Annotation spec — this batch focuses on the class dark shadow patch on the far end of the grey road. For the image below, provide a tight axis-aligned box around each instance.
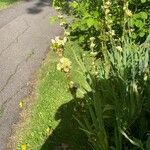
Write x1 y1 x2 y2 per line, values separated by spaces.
27 0 50 14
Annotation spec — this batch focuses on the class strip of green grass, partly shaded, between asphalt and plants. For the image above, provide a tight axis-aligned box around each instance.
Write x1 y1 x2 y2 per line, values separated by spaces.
16 41 90 150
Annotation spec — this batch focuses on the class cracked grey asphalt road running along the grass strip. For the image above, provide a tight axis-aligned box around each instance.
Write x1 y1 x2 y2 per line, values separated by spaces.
0 0 62 150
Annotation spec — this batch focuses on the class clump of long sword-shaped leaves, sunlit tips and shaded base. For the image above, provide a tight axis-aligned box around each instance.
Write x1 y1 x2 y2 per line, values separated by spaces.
74 37 150 150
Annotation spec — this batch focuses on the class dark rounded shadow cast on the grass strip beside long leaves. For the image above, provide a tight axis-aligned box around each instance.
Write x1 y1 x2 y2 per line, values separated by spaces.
41 94 91 150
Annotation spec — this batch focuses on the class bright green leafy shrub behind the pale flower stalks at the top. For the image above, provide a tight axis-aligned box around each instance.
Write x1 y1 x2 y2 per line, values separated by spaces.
55 0 150 47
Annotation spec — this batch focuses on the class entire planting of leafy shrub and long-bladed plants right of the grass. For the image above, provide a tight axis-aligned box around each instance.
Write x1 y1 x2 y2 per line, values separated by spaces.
51 0 150 150
